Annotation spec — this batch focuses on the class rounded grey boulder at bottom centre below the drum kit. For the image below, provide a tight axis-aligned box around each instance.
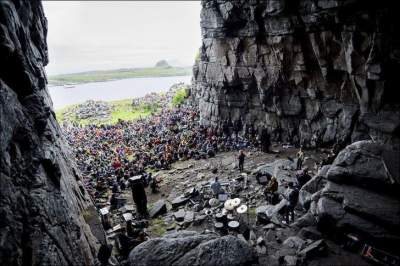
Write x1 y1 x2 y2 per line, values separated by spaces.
129 231 257 266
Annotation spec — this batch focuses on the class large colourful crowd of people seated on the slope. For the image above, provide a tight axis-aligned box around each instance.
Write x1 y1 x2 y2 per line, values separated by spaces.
63 106 257 206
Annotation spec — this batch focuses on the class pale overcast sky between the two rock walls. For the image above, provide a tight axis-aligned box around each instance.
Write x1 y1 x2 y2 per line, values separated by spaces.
43 1 201 75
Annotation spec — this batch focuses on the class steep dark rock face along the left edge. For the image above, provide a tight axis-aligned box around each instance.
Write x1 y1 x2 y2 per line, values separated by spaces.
0 0 98 265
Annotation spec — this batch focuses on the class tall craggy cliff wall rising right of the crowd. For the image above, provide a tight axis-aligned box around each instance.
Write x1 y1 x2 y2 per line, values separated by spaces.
191 0 400 146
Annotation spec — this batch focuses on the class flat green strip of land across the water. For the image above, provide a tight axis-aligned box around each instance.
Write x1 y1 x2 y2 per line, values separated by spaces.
48 67 191 86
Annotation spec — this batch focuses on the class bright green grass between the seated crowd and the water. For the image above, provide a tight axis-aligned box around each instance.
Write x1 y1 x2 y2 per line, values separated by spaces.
56 99 160 125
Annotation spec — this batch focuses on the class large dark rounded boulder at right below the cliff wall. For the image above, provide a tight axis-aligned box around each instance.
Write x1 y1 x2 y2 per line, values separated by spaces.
315 141 400 249
